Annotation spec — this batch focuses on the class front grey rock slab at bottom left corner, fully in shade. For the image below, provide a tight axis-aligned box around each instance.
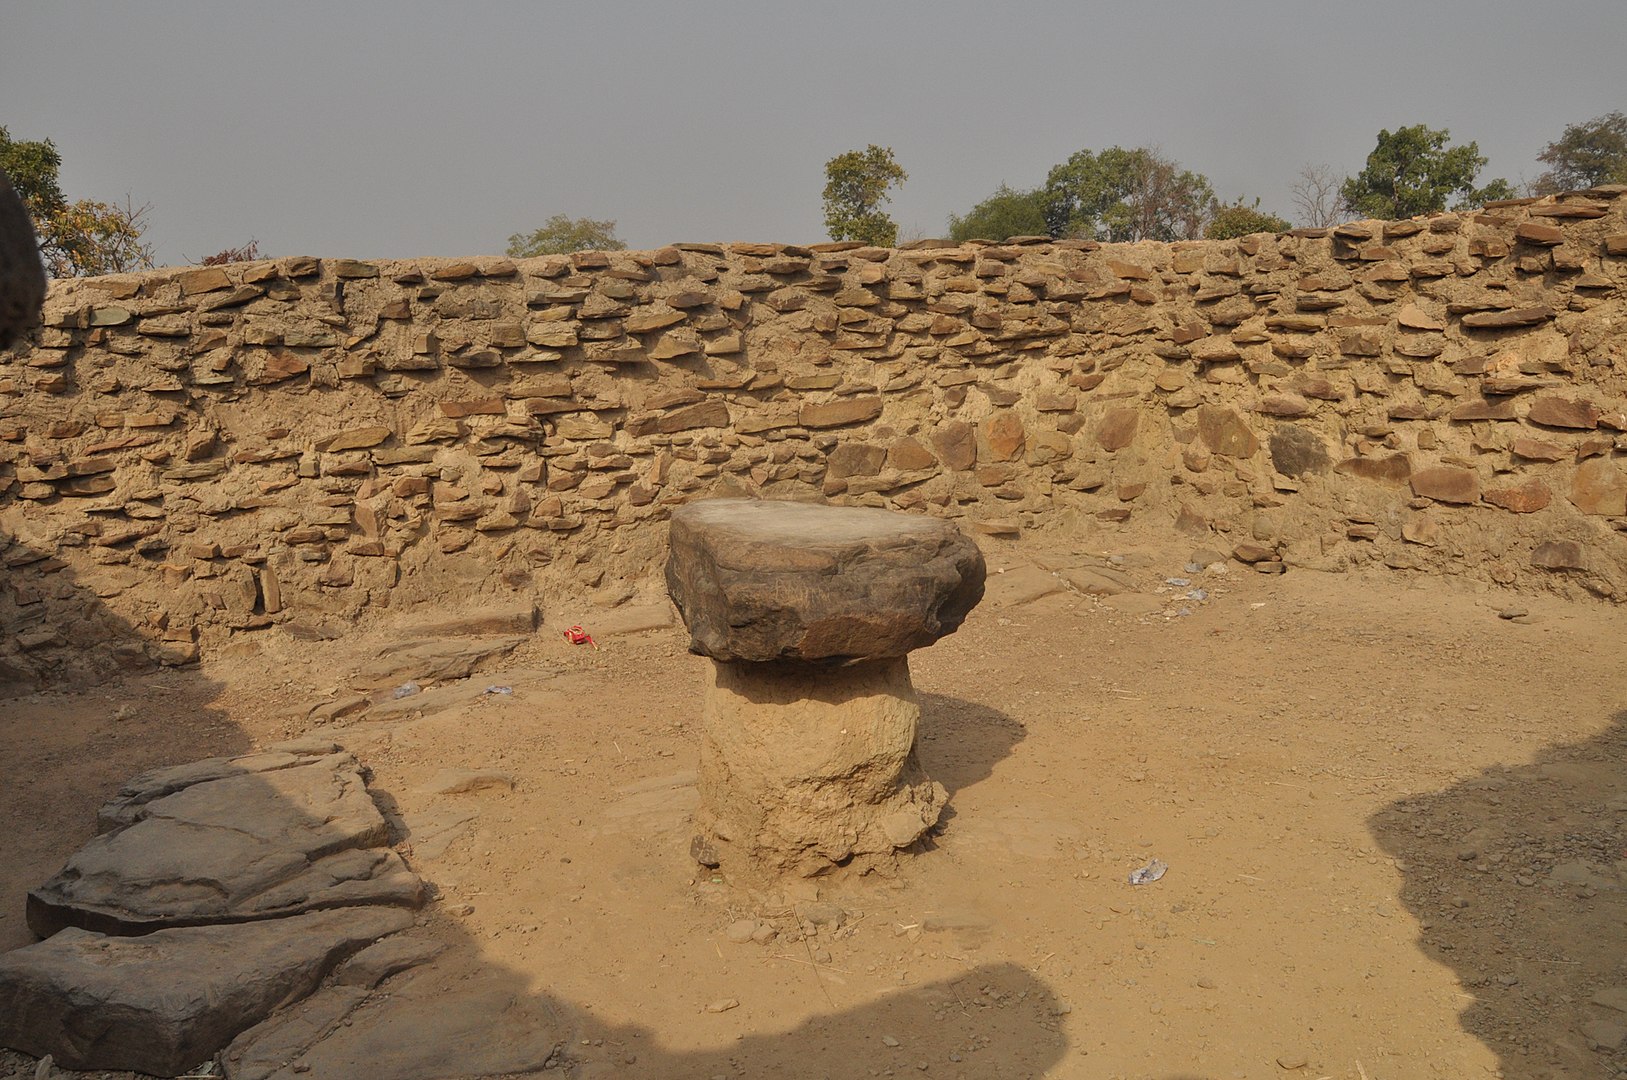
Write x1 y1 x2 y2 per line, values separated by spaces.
0 908 413 1077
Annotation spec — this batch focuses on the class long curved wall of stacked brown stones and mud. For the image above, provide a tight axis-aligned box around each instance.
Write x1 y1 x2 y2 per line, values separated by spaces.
0 187 1627 683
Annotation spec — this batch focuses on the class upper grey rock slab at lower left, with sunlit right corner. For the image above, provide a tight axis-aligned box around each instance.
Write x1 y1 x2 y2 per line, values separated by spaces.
28 753 423 937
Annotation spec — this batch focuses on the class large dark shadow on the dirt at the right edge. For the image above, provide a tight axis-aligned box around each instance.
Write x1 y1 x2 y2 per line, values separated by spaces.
1368 711 1627 1080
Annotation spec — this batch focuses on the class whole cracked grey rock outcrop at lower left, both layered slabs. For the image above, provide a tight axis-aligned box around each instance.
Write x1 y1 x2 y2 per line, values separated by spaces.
0 740 423 1077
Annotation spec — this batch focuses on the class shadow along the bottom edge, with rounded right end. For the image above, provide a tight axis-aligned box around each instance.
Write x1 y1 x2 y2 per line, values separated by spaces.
244 950 1067 1080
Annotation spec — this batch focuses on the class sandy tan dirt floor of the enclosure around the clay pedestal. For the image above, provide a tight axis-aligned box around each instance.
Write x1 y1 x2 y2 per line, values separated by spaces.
0 537 1627 1080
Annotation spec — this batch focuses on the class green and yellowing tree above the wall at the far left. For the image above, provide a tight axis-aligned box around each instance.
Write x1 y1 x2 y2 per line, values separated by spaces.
0 127 153 278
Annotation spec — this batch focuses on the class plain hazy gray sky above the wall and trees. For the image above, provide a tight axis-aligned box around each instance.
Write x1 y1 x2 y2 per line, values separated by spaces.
0 0 1627 263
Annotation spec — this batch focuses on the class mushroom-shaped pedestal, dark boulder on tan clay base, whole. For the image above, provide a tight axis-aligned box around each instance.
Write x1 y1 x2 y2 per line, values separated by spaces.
667 499 984 877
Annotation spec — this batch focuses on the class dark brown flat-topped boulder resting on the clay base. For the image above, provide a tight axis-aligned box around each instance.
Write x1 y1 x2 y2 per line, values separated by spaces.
667 499 984 662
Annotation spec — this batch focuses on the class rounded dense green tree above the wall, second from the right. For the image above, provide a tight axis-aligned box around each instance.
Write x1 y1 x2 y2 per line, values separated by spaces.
1339 124 1515 220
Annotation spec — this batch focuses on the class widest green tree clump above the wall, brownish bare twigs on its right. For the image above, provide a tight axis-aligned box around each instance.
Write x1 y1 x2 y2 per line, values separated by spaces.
1043 146 1215 241
